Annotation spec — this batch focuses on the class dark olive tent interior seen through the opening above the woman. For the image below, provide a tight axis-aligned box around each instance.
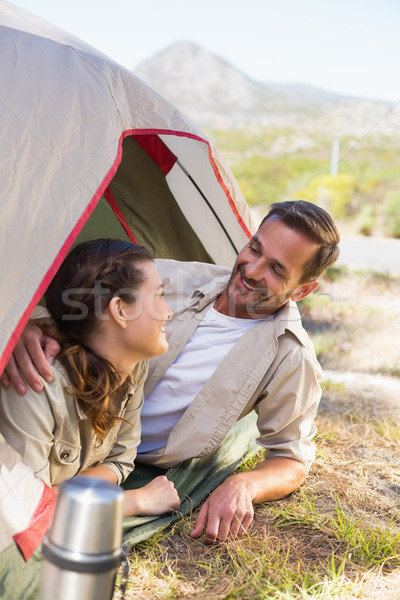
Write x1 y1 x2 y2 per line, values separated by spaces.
74 136 214 263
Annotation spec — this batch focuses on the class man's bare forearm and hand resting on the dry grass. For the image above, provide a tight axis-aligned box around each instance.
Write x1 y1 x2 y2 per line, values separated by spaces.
190 456 307 543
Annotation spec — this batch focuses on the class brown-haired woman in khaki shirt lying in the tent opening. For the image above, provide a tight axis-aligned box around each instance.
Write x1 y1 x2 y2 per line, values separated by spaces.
0 240 179 516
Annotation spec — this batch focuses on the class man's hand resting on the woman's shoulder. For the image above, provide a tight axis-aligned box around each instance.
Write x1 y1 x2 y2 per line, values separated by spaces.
0 323 60 394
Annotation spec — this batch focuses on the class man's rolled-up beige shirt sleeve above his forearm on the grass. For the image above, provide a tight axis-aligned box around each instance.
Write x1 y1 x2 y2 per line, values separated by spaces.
255 347 321 470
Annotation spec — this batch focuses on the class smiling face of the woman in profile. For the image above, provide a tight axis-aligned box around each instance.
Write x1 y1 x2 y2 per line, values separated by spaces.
125 261 172 361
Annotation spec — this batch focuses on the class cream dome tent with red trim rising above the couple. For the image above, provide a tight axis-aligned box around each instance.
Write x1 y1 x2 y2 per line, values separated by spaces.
0 0 252 372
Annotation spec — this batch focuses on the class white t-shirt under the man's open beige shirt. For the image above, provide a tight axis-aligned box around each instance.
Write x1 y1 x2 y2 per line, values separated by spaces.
138 306 259 452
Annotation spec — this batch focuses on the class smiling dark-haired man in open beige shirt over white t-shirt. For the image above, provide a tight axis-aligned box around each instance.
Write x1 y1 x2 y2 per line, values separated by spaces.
3 200 339 543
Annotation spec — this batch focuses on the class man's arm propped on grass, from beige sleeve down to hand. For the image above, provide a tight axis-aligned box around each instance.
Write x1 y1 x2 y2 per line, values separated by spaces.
191 338 321 543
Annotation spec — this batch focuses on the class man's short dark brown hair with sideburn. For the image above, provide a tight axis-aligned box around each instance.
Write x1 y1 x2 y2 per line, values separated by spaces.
260 200 340 283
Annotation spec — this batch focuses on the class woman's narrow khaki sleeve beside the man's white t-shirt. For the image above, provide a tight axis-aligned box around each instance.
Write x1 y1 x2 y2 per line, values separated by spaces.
103 361 148 484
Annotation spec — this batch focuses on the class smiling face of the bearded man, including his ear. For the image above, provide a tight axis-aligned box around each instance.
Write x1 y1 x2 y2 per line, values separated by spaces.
220 218 319 319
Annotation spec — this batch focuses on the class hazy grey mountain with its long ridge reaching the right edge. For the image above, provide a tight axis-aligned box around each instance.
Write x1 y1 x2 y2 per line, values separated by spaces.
134 41 400 136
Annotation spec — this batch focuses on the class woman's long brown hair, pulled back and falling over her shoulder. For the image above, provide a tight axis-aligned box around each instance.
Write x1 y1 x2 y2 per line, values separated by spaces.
43 239 152 442
